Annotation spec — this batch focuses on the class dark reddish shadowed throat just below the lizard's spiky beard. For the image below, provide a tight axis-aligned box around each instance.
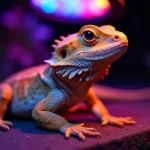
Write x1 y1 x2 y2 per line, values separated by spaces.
52 65 108 97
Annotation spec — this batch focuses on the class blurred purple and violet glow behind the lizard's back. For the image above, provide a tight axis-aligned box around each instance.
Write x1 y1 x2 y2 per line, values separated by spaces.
0 6 55 77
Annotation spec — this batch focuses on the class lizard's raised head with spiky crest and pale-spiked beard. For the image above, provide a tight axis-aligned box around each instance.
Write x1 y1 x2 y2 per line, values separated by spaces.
46 25 128 82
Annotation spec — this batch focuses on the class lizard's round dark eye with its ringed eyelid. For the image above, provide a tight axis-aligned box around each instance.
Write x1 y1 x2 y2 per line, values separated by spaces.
82 31 97 45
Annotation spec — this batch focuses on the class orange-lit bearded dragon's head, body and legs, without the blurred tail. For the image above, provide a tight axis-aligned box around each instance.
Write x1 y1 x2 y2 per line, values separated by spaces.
0 25 135 140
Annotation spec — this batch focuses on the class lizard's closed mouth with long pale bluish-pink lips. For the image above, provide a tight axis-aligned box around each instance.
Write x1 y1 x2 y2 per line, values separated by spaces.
77 44 127 61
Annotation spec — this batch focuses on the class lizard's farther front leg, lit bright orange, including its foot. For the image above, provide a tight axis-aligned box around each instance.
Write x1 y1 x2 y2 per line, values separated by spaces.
85 88 135 127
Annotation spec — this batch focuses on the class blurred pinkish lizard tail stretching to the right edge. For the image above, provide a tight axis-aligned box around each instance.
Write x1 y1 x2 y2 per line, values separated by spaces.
93 84 150 101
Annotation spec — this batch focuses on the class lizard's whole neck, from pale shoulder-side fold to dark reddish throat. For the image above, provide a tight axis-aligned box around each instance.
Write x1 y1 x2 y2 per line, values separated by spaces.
42 65 109 98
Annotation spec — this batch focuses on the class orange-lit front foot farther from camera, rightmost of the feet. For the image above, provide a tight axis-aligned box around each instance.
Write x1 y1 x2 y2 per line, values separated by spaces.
101 115 136 127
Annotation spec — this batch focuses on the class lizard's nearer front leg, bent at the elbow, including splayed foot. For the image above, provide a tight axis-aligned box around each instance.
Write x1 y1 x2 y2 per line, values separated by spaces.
32 90 100 140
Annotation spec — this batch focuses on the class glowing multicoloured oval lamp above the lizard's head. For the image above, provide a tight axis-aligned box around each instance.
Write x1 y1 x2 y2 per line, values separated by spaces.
31 0 111 23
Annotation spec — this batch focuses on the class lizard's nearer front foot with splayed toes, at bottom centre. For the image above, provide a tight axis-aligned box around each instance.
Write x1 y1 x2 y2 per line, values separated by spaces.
60 124 101 141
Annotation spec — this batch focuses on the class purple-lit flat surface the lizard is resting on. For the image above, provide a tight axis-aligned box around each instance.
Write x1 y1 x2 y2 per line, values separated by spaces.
0 101 150 150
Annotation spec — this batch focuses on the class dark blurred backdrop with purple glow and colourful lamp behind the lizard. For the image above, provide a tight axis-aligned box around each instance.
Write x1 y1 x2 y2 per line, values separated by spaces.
0 0 150 87
